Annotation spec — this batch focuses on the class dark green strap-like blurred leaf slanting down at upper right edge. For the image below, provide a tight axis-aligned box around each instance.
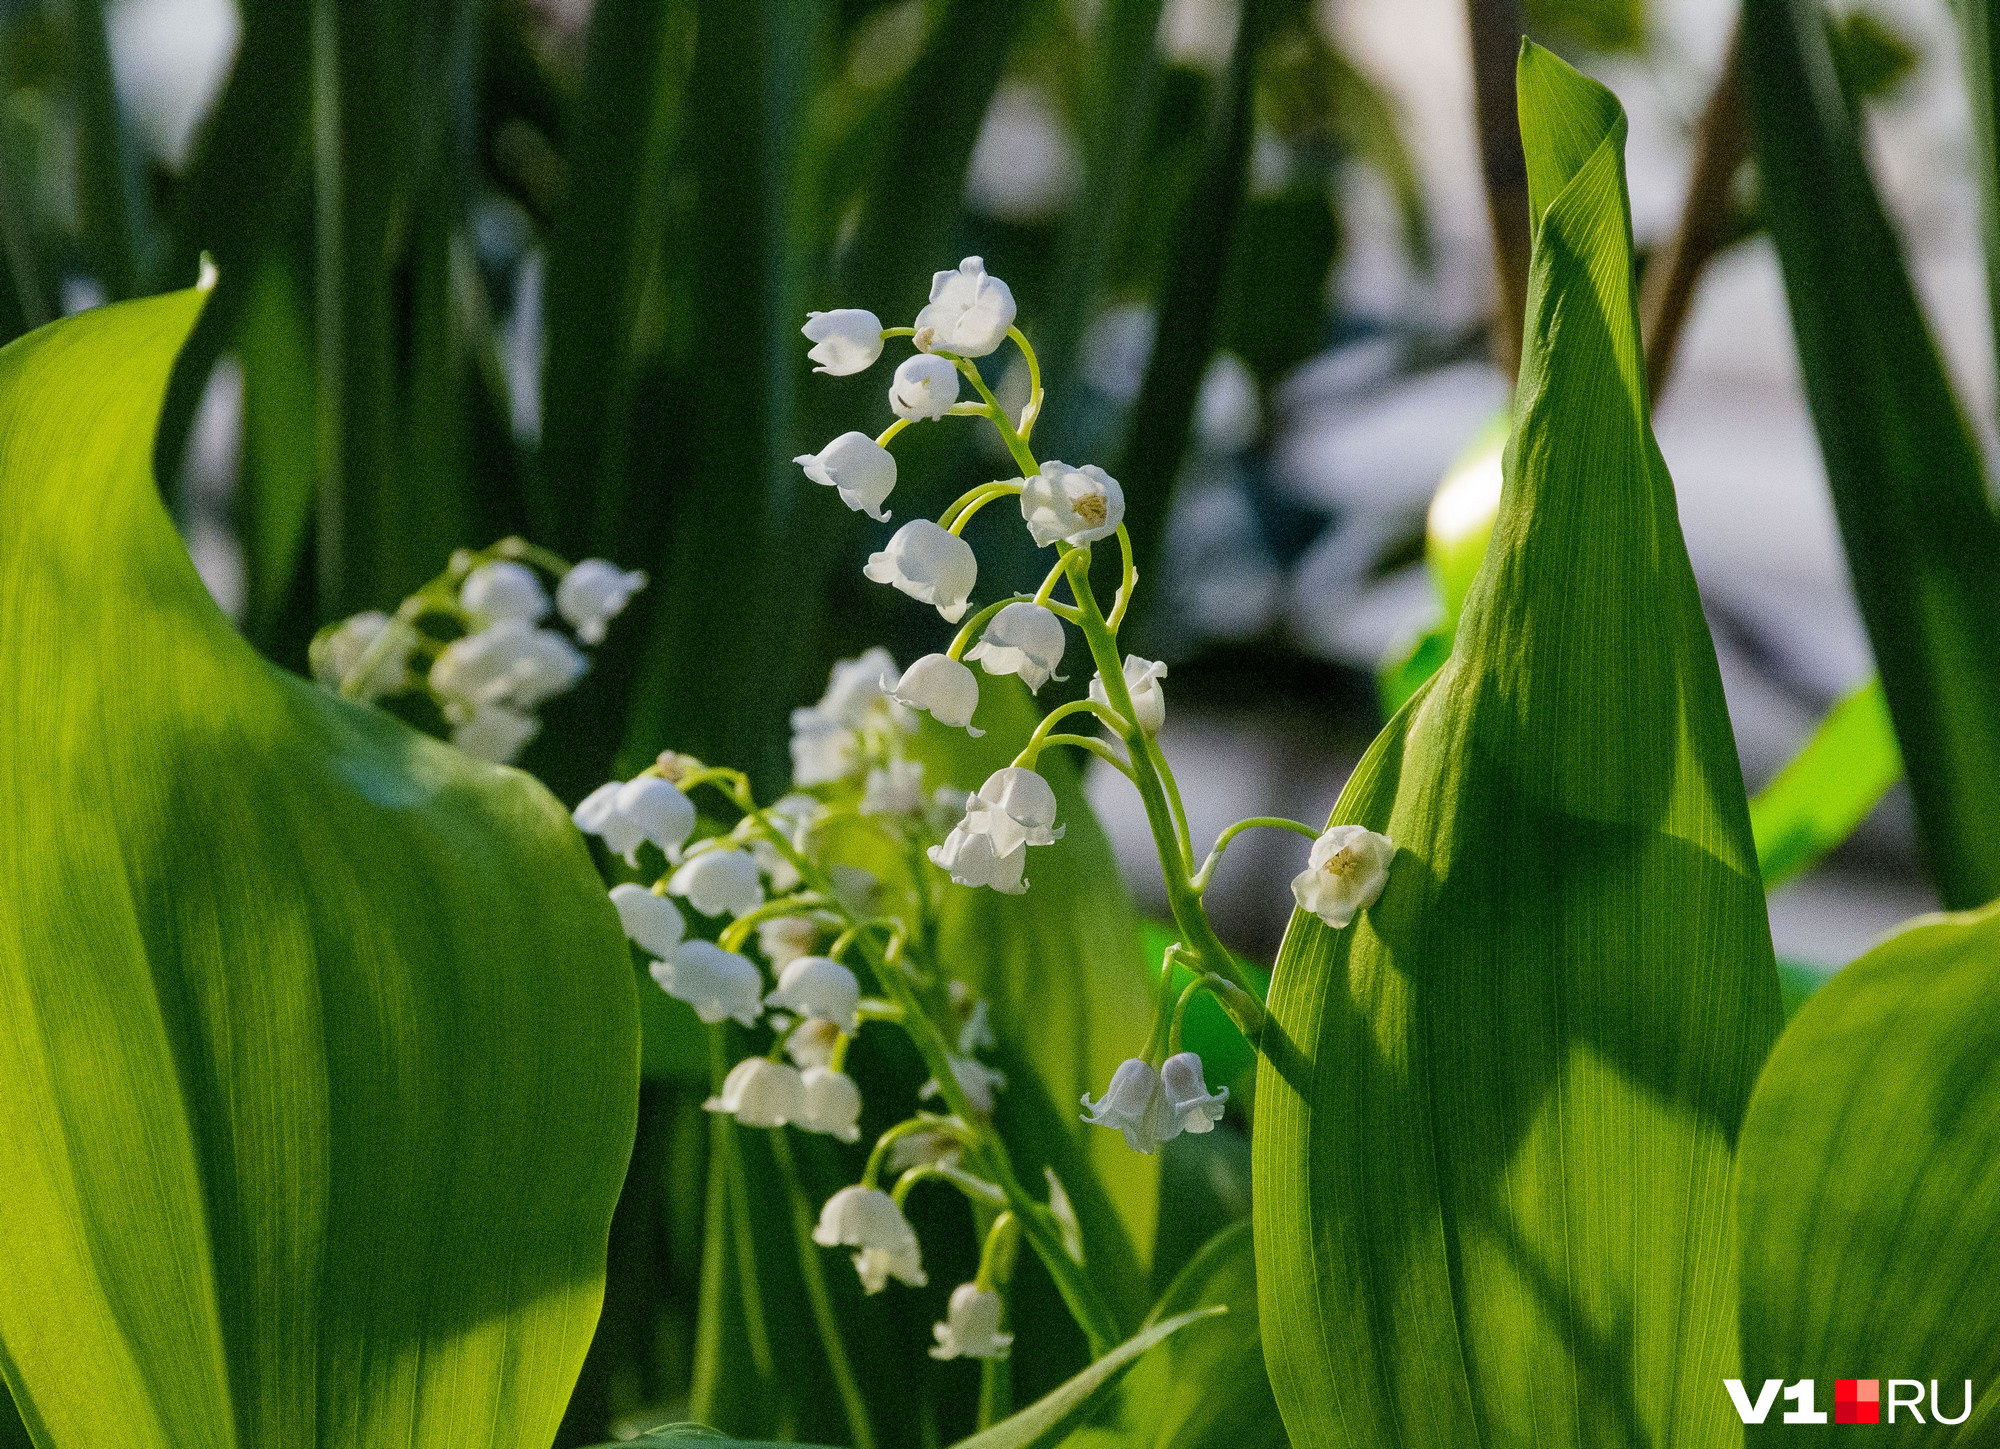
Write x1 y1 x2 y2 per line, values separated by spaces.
1742 0 2000 907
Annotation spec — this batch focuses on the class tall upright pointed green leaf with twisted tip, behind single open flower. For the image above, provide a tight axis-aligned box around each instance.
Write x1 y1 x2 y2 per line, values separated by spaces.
1252 46 1780 1449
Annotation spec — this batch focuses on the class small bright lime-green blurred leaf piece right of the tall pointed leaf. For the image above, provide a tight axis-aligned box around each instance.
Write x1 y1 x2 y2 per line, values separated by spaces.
1750 678 1902 887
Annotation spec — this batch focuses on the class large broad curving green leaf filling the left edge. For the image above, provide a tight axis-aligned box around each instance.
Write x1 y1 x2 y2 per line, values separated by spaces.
0 292 638 1449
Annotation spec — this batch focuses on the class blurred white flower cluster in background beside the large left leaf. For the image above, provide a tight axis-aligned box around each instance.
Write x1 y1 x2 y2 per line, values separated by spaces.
312 540 646 765
